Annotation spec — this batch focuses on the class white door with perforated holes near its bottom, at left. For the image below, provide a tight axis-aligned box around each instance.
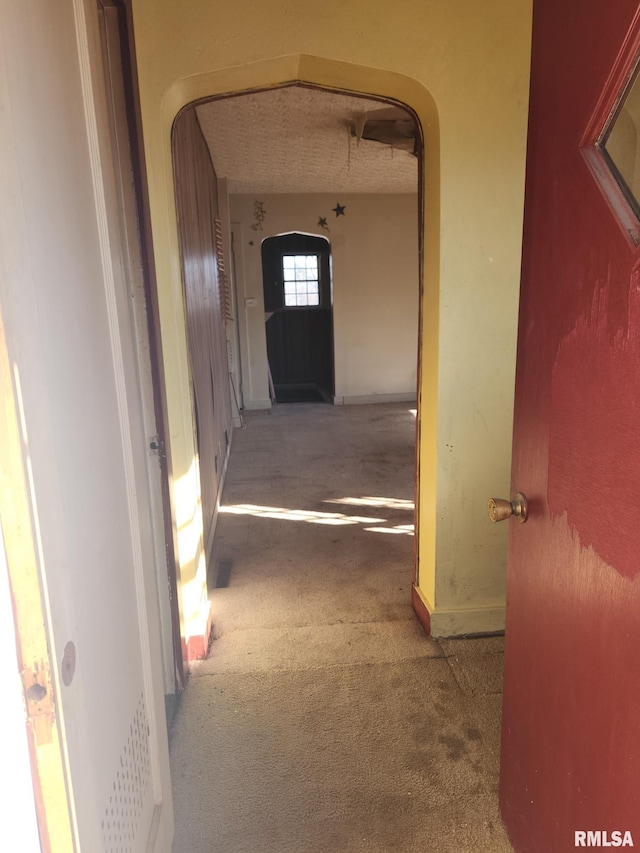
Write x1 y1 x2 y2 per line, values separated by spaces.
0 0 172 853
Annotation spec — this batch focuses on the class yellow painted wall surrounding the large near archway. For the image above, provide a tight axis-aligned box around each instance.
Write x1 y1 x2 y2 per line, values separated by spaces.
133 0 531 634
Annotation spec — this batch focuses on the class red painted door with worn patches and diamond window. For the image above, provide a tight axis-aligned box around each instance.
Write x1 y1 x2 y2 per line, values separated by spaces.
501 0 640 853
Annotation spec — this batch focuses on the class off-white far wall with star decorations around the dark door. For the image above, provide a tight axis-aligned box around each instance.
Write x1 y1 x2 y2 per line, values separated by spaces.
230 194 418 408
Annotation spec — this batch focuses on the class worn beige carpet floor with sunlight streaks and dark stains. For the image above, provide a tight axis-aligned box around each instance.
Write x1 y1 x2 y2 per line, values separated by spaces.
171 404 511 853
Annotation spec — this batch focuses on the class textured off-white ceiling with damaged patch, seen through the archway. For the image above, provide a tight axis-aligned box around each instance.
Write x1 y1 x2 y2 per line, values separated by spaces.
197 86 418 194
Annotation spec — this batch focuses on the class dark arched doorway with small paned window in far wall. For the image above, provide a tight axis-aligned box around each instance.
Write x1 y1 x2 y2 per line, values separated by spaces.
262 233 334 403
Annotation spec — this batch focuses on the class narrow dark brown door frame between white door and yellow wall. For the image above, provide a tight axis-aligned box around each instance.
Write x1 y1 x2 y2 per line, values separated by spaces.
97 0 188 693
